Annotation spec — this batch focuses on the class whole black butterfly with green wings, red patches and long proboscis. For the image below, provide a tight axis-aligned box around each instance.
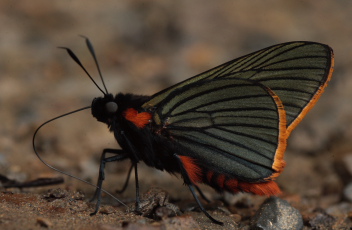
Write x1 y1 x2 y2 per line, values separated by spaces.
33 38 334 224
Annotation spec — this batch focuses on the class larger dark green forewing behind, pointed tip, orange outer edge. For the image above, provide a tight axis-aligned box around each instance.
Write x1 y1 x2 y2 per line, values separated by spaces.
143 42 333 134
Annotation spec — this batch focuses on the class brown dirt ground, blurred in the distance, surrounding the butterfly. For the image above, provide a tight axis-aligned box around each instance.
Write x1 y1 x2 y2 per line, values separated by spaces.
0 0 352 229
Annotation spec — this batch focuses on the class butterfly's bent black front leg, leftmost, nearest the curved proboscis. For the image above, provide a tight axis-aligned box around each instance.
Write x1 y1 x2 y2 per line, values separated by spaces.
90 149 128 215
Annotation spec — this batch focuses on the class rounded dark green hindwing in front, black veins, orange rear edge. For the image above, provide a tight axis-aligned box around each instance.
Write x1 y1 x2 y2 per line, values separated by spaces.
153 78 287 182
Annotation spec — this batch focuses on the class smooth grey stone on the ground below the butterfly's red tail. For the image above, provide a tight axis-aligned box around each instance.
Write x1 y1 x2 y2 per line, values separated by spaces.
251 197 303 230
